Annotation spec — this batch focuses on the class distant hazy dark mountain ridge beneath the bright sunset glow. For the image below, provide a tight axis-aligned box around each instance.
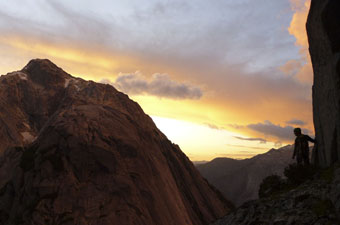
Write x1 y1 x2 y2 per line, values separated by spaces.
196 145 294 206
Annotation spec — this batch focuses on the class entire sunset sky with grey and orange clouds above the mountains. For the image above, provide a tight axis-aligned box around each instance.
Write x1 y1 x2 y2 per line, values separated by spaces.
0 0 314 161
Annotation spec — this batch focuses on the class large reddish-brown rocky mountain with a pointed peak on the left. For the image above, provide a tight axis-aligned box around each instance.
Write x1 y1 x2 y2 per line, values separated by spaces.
0 59 232 225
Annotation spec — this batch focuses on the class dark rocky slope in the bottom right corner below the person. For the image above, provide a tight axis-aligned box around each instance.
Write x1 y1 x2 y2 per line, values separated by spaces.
213 169 340 225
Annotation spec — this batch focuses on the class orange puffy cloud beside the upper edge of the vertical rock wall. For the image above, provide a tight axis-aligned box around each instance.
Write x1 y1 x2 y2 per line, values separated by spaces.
280 0 313 84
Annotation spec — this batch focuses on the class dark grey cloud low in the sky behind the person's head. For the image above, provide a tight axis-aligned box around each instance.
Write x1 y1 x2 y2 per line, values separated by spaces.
247 120 309 141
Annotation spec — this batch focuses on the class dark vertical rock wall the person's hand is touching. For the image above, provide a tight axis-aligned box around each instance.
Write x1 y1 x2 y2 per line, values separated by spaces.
307 0 340 166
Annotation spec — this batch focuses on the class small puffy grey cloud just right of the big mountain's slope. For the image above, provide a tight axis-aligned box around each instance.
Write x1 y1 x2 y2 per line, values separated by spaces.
101 72 203 99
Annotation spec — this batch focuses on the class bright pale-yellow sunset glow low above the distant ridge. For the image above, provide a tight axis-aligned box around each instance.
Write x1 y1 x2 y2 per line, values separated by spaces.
151 116 274 161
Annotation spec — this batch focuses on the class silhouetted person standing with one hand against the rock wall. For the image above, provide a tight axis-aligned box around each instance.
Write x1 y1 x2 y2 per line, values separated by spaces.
293 128 315 165
